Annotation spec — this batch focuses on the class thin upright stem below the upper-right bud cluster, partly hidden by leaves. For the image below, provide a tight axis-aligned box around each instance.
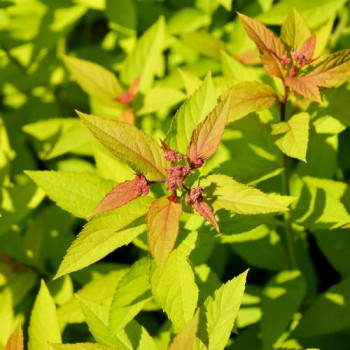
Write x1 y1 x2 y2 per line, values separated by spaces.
280 86 297 269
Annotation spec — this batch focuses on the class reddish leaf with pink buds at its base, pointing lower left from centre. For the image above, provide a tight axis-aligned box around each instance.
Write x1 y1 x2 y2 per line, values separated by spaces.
87 175 149 217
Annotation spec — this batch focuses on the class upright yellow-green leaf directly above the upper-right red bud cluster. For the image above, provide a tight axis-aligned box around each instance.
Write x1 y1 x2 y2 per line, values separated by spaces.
281 8 311 49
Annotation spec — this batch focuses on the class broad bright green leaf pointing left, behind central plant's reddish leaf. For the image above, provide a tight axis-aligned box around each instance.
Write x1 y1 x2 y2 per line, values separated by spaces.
25 171 114 218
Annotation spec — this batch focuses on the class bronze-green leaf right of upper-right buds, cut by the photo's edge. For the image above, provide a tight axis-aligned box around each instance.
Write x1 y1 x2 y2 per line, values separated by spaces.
307 49 350 87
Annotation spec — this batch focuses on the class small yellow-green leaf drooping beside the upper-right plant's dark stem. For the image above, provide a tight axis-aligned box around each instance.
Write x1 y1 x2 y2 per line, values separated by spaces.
272 112 310 162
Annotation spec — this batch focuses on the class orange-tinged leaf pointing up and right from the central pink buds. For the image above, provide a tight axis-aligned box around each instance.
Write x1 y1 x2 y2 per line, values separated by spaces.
187 94 231 162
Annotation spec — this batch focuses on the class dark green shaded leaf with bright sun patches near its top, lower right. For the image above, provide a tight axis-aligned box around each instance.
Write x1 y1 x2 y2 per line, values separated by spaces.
261 271 306 347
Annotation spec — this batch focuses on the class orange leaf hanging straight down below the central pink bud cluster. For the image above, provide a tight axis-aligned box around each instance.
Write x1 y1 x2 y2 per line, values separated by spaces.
146 197 182 267
